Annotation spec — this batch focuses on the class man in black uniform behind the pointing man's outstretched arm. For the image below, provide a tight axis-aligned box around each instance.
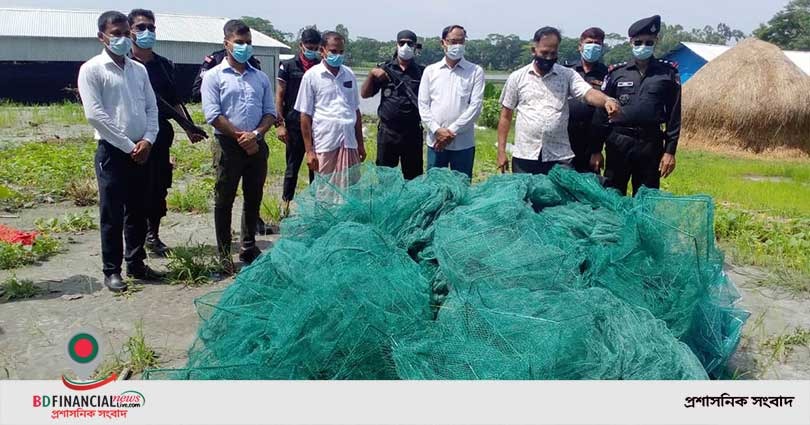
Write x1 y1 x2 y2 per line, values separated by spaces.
566 27 607 173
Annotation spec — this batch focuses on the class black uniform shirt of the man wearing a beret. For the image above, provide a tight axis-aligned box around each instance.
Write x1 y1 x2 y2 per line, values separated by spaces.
603 58 681 154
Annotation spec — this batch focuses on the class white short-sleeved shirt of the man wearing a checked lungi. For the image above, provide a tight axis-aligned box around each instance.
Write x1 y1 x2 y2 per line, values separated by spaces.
295 62 360 153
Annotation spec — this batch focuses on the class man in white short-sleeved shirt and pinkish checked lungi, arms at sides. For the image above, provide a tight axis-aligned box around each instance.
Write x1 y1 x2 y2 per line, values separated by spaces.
295 31 366 186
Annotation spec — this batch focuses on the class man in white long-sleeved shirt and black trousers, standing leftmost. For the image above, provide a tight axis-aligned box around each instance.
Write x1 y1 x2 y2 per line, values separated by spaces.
78 11 162 292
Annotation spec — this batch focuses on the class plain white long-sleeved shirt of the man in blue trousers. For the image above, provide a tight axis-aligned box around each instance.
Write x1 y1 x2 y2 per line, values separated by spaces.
419 59 484 151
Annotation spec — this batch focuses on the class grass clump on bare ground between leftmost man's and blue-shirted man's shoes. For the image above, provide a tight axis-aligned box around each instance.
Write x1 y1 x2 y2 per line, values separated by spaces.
166 245 222 286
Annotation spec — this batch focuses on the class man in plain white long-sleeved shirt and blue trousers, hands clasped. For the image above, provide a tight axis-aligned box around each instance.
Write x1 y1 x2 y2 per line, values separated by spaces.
419 25 484 178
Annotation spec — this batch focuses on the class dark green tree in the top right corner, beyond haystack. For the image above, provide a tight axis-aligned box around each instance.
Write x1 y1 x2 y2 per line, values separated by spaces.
754 0 810 50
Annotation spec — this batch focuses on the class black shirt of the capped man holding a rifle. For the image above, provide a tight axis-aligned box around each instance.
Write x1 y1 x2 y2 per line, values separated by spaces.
374 58 425 130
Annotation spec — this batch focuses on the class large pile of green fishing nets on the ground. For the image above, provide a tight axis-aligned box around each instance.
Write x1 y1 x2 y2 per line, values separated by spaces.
146 166 748 379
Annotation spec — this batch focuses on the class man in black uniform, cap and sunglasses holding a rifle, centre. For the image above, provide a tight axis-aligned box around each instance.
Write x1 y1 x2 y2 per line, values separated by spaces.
360 30 425 180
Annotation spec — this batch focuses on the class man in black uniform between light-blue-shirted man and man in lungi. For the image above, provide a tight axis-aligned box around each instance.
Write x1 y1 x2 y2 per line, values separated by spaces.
276 28 321 217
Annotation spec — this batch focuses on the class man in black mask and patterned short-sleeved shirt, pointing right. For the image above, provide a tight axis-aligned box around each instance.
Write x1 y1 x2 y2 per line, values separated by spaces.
498 27 620 174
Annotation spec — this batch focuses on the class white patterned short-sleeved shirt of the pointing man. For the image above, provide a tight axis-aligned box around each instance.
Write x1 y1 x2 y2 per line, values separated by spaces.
501 62 592 161
